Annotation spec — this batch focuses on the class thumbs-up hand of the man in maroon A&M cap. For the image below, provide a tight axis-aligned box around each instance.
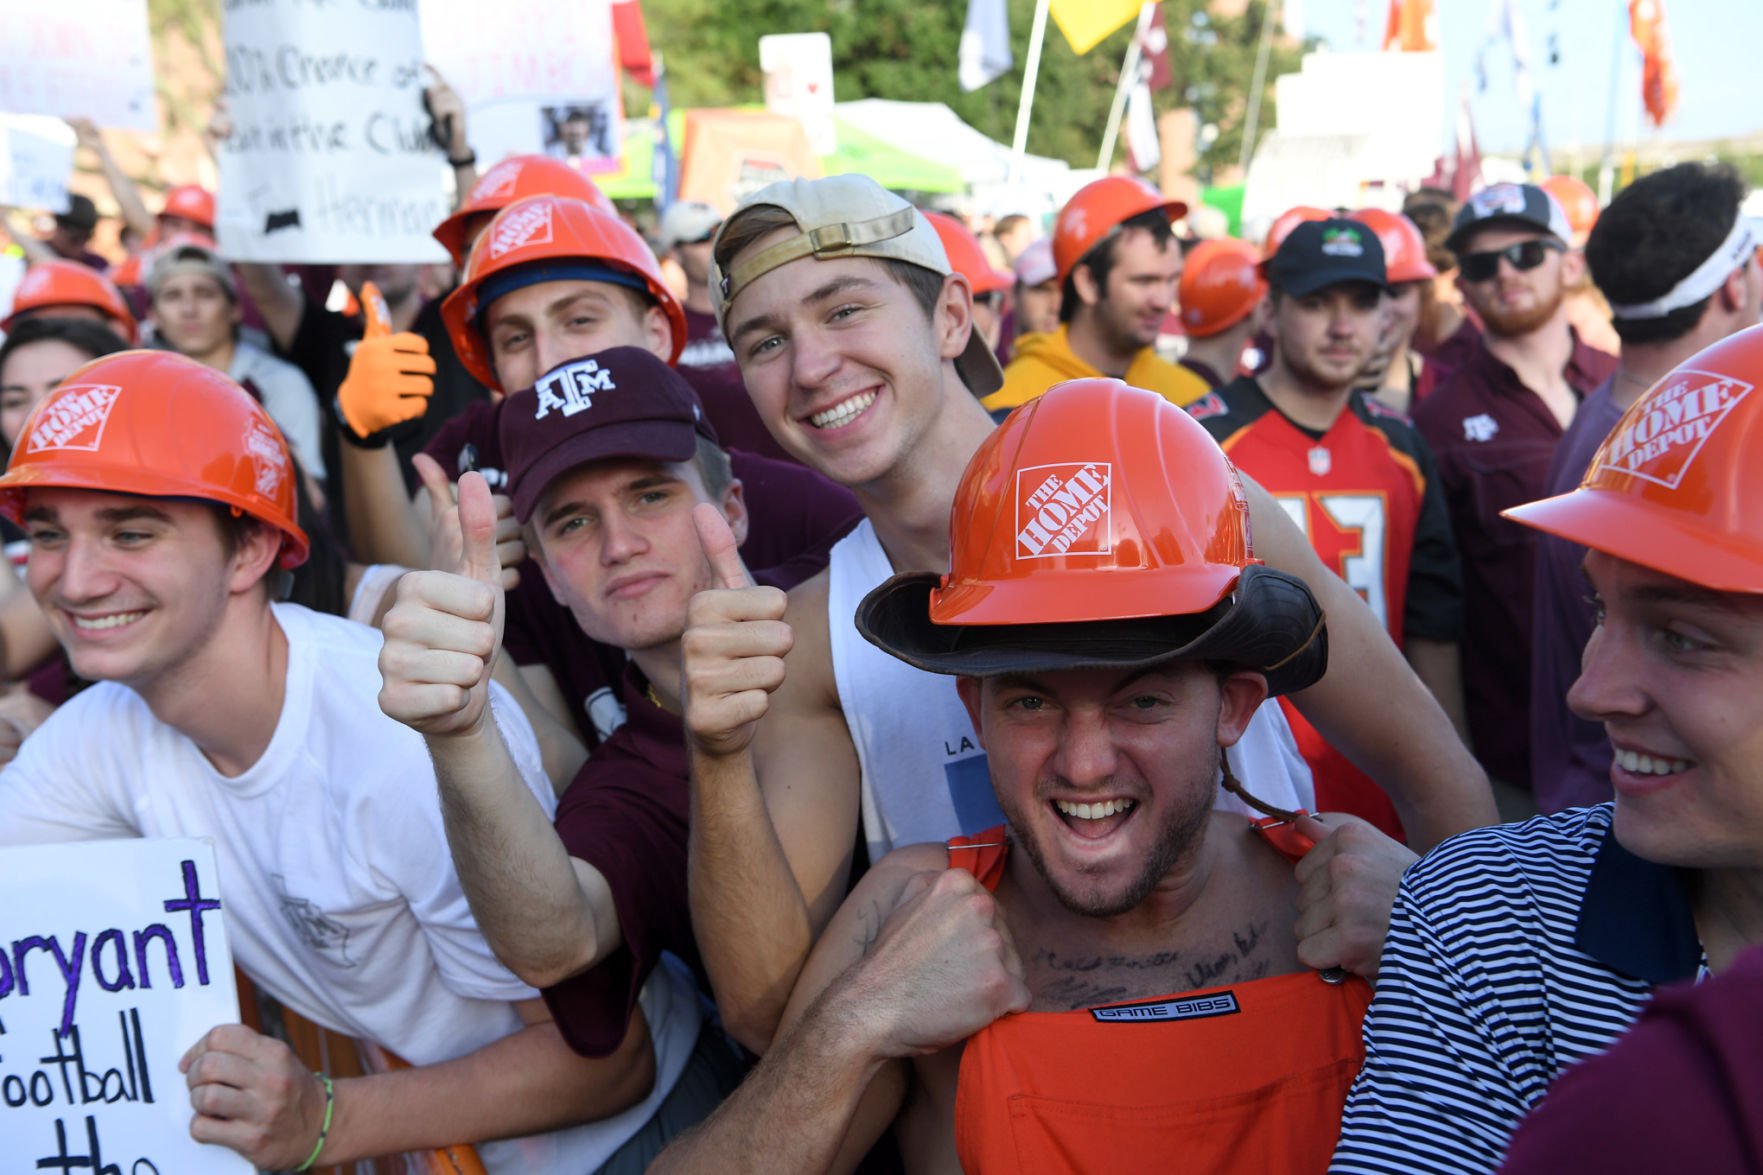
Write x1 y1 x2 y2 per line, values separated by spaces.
379 473 502 736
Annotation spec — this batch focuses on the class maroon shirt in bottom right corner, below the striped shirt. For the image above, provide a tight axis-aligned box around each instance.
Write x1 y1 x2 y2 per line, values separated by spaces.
1500 947 1763 1175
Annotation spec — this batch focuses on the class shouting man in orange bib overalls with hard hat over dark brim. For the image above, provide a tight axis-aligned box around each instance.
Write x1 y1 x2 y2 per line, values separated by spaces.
658 379 1370 1173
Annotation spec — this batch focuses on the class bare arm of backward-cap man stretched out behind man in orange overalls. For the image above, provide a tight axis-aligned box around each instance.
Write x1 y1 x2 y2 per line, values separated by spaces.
1243 476 1499 850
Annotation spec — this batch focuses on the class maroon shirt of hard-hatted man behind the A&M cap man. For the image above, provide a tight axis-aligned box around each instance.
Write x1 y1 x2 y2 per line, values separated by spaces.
423 400 862 746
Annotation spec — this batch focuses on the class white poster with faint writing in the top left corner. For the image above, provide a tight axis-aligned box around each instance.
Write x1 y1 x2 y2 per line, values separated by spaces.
0 0 159 131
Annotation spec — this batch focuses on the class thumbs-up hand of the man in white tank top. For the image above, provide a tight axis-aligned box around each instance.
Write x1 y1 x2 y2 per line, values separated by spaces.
681 503 795 757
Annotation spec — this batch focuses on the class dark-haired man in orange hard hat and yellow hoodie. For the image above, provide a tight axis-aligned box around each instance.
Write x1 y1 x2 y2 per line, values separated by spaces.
986 175 1206 411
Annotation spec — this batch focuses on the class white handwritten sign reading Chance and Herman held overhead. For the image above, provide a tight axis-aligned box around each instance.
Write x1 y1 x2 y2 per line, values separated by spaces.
217 0 451 261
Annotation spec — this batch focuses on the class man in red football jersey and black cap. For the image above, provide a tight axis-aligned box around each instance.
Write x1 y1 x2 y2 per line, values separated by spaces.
1188 219 1463 836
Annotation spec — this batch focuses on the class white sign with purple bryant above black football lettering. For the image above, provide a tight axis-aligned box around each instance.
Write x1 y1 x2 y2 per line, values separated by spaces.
0 840 252 1175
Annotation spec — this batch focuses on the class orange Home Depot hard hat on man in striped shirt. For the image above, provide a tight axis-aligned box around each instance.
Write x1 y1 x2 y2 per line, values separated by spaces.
1506 326 1763 593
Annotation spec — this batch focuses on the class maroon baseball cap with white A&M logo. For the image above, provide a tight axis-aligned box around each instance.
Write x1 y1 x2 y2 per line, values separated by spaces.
501 348 716 522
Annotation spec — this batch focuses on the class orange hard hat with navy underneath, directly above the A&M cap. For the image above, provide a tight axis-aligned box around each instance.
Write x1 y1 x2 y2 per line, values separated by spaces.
441 196 686 392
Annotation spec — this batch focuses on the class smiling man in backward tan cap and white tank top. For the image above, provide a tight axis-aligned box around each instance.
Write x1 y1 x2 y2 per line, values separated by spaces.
686 166 1493 1050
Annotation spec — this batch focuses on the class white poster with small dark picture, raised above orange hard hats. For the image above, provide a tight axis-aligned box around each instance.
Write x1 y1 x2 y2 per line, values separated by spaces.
421 0 624 173
